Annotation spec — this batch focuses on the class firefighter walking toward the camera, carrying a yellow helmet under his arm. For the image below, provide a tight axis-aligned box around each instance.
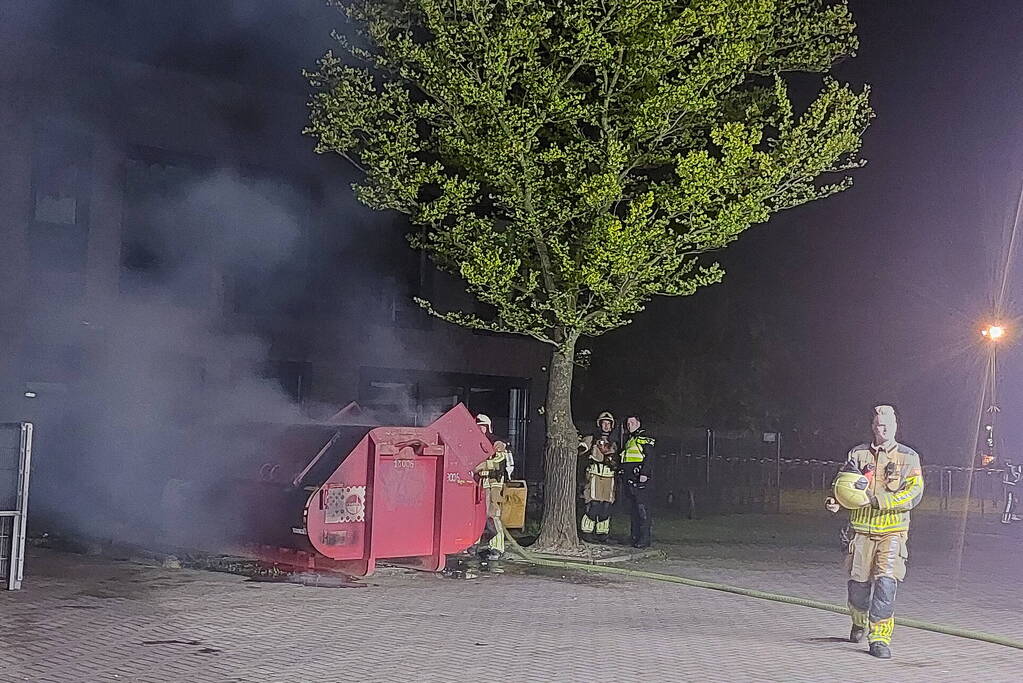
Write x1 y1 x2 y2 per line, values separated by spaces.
825 406 924 659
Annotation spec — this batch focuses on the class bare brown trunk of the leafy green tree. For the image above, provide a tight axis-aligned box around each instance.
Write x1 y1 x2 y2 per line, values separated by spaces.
535 334 581 550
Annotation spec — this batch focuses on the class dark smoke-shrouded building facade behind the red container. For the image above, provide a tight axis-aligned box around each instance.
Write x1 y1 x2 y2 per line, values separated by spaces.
0 1 546 531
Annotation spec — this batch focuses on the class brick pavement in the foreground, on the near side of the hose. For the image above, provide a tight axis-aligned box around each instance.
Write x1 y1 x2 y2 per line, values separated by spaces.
0 550 1023 683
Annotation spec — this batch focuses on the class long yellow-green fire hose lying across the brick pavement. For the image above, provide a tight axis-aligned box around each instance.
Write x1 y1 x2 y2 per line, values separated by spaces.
504 529 1023 649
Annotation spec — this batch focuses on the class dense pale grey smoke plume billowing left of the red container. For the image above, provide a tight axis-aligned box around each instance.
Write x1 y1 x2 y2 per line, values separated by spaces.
33 166 317 540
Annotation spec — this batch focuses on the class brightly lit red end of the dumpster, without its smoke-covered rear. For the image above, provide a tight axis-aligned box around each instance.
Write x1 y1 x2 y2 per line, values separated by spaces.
305 404 493 576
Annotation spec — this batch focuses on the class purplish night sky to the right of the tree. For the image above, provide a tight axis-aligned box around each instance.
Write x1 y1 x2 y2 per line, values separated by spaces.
589 0 1023 464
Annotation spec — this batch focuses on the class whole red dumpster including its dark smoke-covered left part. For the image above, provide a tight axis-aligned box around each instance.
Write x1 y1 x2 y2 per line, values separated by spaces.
161 404 493 576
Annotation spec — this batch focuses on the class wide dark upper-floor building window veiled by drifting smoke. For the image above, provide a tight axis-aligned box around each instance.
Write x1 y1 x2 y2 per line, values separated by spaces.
121 152 313 315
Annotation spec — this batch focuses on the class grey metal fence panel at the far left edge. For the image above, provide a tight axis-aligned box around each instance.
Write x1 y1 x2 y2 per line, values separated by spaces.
0 422 32 590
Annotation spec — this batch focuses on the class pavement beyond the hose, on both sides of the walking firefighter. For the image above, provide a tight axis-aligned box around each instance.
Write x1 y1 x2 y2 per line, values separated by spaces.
637 515 1023 642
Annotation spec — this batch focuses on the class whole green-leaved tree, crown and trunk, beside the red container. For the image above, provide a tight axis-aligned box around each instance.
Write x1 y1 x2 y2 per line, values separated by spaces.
307 0 873 548
